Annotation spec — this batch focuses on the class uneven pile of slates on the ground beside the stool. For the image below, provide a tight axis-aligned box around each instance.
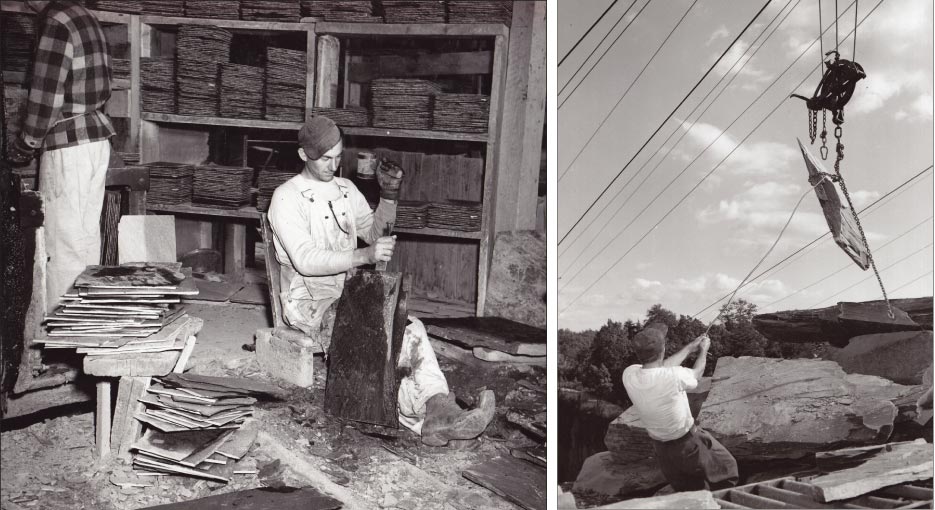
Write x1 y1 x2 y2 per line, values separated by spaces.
131 374 283 483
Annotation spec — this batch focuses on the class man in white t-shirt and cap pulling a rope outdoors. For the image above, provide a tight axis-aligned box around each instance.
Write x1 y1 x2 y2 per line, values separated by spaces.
623 323 738 492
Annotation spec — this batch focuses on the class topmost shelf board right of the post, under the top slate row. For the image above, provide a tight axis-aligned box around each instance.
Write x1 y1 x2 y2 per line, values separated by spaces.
310 18 509 37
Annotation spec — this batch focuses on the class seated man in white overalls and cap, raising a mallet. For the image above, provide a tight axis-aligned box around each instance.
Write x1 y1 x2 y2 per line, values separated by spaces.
269 116 495 446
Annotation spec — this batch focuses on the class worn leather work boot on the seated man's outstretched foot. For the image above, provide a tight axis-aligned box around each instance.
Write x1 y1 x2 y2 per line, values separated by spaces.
422 390 497 446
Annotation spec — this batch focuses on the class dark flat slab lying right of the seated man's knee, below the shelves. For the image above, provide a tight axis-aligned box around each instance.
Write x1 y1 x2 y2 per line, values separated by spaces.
422 317 548 356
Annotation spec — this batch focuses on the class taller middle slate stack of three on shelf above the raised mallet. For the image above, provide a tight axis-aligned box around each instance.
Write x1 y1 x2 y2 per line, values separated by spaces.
370 78 441 129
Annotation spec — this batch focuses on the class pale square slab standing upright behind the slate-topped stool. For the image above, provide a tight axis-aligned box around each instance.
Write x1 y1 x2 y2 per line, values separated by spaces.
117 214 176 264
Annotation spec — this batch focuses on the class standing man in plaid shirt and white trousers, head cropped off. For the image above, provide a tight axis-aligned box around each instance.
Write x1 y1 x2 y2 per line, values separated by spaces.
9 0 115 309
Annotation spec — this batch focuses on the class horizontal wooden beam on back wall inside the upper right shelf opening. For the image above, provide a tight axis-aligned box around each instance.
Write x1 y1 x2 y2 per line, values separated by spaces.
347 51 494 82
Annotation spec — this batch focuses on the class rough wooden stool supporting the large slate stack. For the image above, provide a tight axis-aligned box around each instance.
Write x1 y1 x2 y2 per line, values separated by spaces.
83 316 204 459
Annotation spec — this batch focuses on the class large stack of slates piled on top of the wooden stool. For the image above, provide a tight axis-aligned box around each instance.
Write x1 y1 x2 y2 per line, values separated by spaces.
37 262 198 340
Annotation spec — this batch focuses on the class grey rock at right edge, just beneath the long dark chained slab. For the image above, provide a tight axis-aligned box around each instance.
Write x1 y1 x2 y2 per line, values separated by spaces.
824 331 932 384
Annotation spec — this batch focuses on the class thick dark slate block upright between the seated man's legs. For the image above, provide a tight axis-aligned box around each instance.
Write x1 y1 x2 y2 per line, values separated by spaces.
325 269 405 428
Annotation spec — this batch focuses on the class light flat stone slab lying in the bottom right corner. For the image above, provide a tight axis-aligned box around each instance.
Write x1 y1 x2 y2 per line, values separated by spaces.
809 439 933 502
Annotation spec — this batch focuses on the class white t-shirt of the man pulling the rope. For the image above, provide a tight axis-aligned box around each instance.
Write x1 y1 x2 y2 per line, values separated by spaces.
623 365 698 441
